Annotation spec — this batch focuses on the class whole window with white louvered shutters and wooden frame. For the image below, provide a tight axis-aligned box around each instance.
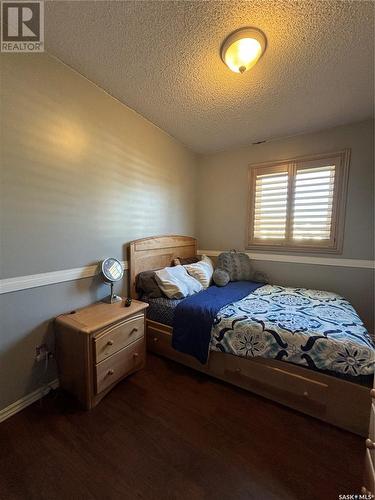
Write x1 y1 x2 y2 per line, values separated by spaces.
248 150 350 253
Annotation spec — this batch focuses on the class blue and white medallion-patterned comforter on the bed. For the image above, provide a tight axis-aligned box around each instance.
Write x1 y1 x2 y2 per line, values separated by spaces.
210 285 375 376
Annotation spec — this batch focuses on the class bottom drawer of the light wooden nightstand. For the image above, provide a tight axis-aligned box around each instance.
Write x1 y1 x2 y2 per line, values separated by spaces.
95 338 145 394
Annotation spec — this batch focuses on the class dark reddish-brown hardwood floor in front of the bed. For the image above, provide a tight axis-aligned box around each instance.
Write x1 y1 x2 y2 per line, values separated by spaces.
0 355 364 500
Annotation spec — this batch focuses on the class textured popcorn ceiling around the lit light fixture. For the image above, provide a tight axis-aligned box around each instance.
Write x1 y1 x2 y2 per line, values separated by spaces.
45 0 374 152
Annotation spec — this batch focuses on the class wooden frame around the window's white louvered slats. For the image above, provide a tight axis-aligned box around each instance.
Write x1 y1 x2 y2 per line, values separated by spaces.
246 149 351 254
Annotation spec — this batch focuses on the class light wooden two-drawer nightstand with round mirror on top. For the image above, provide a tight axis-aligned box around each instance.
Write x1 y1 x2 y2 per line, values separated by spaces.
55 300 148 410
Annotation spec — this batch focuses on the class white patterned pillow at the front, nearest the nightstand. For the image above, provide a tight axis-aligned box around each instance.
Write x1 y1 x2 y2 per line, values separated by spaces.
155 266 203 299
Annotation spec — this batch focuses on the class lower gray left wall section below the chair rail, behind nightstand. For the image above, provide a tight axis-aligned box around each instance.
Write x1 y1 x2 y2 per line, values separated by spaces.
0 279 108 410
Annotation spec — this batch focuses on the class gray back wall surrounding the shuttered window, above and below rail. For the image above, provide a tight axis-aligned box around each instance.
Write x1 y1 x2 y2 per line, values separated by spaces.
197 120 374 332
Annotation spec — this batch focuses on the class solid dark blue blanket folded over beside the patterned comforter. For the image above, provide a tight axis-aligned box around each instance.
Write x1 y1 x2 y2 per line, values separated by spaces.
172 281 263 364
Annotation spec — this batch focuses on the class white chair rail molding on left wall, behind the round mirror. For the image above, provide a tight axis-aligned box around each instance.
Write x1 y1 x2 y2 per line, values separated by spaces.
0 261 128 295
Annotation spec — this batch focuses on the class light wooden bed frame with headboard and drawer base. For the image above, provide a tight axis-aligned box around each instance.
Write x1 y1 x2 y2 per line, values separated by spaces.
129 236 371 436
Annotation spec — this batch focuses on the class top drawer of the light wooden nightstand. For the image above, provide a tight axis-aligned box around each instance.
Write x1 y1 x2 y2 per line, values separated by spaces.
94 315 144 363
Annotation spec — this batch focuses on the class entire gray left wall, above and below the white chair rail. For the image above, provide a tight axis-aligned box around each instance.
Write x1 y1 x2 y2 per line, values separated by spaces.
0 54 196 409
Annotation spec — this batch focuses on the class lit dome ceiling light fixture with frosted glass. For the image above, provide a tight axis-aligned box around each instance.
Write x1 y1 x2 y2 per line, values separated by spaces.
221 28 267 73
